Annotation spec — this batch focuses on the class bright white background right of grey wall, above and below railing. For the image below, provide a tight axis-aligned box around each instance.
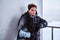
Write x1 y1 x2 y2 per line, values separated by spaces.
43 0 60 40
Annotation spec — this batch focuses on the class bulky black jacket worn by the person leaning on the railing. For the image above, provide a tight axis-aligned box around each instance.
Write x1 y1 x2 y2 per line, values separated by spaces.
18 11 47 40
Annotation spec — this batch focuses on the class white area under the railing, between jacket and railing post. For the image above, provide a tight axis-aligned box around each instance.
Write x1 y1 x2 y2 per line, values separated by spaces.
43 27 52 40
